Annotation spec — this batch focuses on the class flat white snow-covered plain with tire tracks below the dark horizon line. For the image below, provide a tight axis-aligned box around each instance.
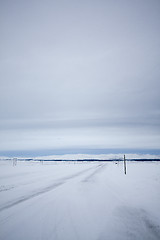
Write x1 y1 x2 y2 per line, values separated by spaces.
0 161 160 240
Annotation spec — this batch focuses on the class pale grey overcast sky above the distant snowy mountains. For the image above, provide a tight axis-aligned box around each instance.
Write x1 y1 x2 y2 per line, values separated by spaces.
0 0 160 156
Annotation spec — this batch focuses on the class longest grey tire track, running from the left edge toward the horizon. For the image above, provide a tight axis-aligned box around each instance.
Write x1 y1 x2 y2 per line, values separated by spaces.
0 165 100 212
